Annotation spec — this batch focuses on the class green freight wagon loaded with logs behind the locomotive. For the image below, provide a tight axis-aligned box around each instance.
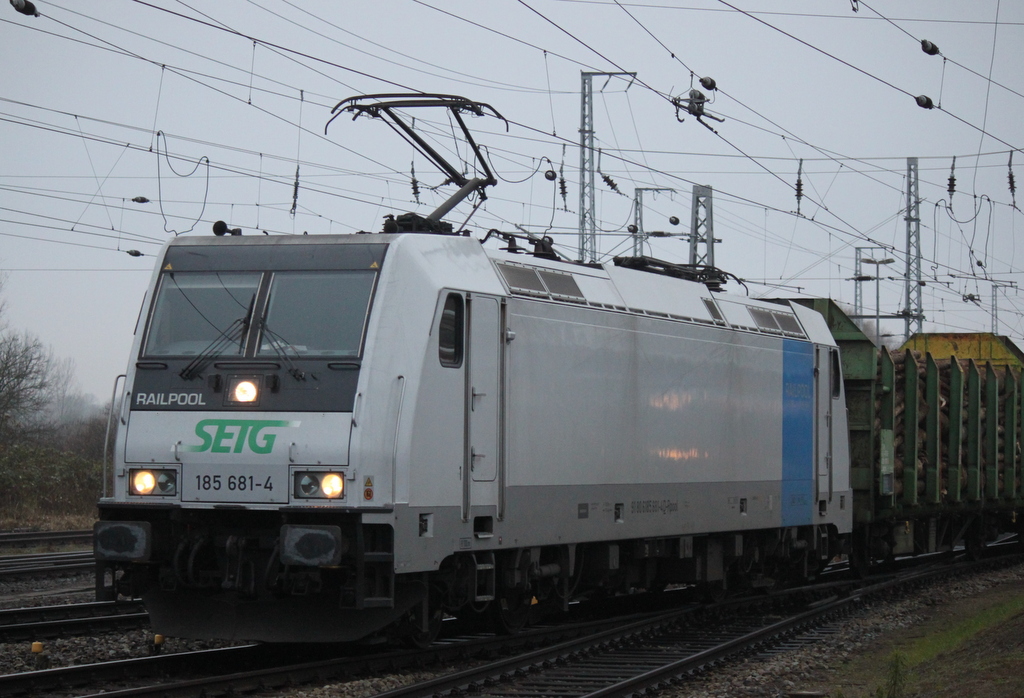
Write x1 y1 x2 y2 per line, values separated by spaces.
795 299 1024 564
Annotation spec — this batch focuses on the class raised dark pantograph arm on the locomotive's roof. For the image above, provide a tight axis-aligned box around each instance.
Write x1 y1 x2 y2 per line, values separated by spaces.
324 92 508 222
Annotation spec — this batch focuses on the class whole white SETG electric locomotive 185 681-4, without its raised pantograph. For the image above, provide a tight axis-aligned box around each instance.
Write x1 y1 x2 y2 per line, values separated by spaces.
95 233 853 642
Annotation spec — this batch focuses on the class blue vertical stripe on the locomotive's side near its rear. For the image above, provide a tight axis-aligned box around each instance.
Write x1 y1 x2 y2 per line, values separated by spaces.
782 340 814 526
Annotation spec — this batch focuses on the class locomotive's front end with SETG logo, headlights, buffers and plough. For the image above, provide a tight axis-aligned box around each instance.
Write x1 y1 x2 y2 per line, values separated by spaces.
95 237 413 640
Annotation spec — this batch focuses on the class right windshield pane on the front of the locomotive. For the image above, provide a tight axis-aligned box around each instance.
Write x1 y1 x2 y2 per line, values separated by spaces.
257 271 377 356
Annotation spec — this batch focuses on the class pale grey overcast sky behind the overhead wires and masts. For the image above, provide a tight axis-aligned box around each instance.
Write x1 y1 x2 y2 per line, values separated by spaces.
0 0 1024 401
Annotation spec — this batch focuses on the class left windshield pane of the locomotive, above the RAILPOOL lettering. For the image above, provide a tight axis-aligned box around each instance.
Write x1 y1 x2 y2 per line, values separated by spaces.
144 271 261 356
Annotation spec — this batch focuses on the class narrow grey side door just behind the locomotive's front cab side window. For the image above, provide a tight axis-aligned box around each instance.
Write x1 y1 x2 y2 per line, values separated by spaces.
462 294 502 521
